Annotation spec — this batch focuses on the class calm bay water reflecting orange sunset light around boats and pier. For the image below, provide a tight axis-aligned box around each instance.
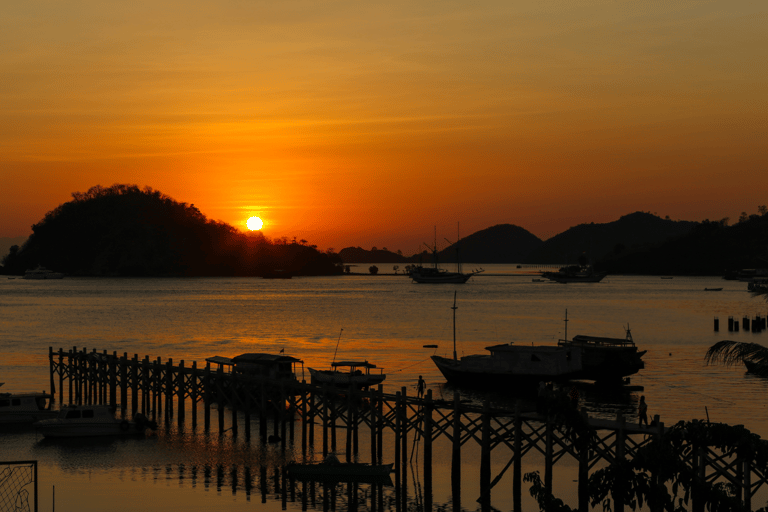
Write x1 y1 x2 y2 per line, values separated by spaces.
0 265 768 511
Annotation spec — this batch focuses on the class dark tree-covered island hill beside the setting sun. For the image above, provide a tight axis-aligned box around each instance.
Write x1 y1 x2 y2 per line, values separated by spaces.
3 185 342 276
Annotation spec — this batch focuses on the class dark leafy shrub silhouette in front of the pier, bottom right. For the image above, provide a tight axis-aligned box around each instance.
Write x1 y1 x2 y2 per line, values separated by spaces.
525 396 768 512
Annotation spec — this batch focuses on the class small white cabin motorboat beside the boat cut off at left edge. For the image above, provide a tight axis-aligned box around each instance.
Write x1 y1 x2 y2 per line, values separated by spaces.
33 405 157 438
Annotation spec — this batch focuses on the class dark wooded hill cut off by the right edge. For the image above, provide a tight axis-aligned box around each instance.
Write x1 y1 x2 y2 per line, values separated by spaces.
596 215 768 275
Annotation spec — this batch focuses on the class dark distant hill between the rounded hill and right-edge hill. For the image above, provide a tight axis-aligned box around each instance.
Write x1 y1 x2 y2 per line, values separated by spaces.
525 212 698 264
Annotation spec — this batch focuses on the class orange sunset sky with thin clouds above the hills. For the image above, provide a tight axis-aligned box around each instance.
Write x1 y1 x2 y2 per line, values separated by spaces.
0 0 768 254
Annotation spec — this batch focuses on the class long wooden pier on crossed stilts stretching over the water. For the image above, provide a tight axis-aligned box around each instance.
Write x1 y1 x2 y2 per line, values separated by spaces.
49 347 768 512
